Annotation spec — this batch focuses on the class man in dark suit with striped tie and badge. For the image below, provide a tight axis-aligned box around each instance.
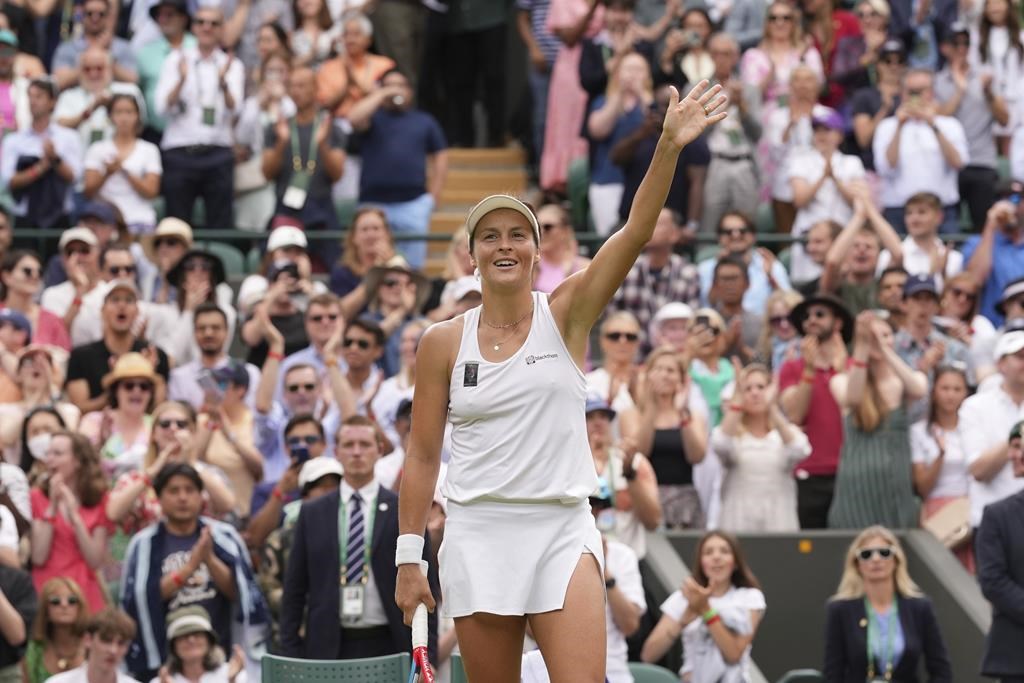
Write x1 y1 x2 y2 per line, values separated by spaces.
281 415 440 659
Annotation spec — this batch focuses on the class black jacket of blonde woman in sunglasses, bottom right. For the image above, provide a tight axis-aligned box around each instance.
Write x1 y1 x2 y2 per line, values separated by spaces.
824 597 953 683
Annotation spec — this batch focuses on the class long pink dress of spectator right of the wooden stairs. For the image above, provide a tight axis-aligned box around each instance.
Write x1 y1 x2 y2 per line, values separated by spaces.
541 0 604 189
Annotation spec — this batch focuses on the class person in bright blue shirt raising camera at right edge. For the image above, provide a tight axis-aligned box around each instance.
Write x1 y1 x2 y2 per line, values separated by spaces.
961 180 1024 325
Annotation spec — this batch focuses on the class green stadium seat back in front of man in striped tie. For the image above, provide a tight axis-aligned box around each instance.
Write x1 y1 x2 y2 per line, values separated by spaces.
260 652 412 683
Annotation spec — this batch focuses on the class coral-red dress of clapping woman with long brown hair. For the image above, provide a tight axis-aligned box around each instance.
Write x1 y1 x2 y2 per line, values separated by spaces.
31 488 114 614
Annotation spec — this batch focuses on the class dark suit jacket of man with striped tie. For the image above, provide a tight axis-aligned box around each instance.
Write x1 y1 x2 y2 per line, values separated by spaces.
281 486 440 661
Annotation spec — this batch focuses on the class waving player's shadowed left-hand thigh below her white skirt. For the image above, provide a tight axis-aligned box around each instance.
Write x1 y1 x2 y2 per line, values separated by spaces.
455 612 528 683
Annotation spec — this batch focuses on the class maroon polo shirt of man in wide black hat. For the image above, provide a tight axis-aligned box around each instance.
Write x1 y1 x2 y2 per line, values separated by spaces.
778 358 843 478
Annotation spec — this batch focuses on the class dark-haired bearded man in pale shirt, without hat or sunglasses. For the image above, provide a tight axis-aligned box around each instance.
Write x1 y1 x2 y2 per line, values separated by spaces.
167 301 260 411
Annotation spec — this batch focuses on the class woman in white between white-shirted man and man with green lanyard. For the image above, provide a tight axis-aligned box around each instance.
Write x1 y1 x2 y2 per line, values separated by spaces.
234 50 295 232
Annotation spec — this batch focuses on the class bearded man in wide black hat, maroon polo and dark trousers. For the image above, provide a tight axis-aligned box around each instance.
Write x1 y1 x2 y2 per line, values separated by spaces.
778 294 853 528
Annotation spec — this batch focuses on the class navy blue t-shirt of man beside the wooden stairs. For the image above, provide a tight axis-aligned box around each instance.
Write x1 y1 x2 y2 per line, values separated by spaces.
358 109 447 204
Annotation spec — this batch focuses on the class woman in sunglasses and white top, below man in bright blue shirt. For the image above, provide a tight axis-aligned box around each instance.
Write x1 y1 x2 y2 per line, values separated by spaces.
935 272 999 385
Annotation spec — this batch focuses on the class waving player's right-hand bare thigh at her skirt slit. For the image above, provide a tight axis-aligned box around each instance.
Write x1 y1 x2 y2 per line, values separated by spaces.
529 553 607 683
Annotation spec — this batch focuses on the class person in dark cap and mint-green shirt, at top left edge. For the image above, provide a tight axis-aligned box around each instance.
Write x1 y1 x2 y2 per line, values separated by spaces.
133 0 196 142
